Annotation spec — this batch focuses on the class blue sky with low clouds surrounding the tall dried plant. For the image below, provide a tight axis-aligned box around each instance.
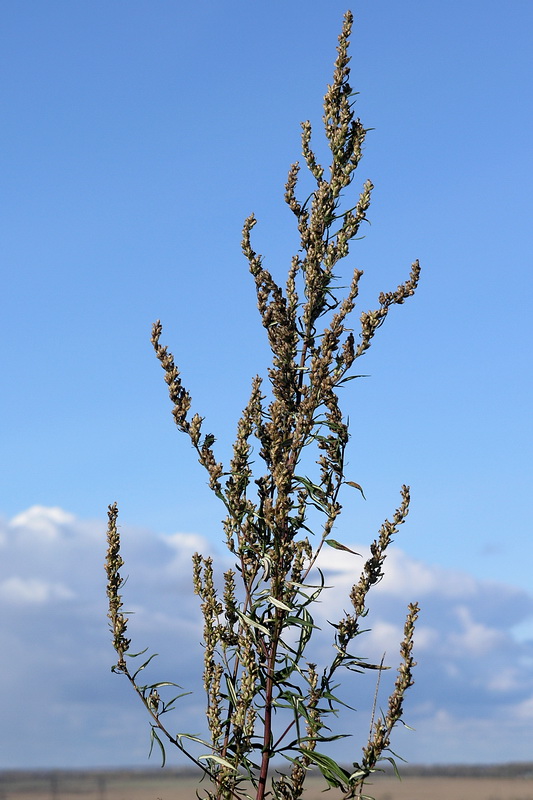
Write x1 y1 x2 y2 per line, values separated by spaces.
0 0 533 767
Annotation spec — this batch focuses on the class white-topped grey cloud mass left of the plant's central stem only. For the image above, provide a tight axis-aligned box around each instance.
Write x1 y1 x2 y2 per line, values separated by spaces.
0 506 212 768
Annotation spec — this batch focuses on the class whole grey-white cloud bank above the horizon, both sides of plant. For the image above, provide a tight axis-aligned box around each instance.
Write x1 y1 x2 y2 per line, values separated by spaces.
0 506 533 768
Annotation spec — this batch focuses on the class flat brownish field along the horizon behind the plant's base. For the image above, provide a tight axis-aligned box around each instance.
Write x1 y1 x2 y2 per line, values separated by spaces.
0 771 533 800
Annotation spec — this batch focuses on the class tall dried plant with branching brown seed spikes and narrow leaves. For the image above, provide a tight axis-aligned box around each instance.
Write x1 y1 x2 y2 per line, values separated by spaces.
106 12 420 800
